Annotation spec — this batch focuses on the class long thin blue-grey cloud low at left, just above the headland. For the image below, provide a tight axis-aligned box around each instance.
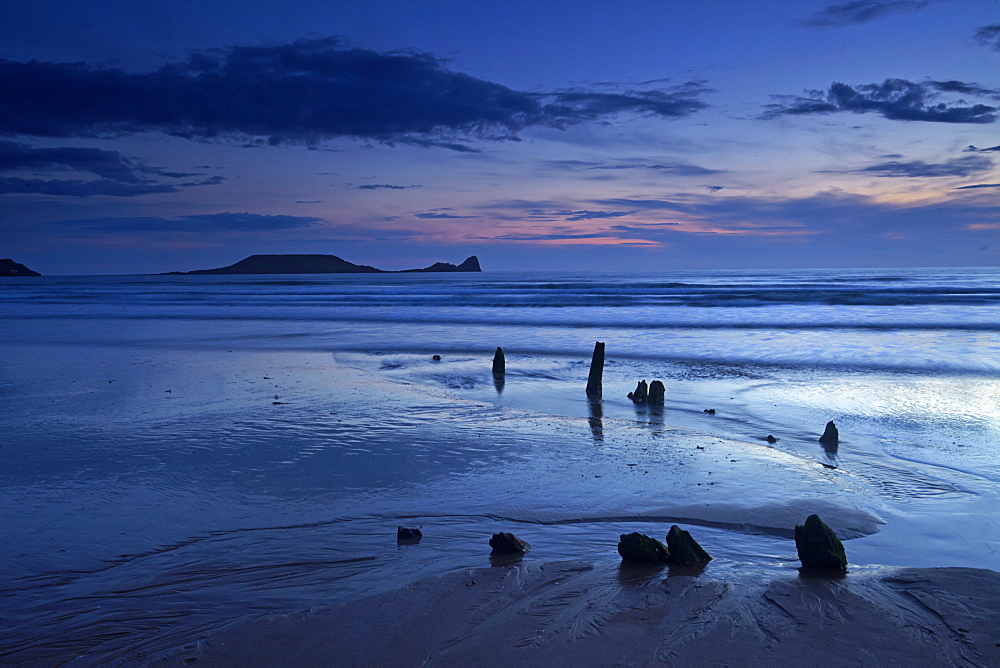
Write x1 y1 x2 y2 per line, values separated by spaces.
49 212 322 234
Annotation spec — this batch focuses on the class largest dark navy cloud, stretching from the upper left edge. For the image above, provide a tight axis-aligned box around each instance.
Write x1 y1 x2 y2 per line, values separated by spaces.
0 37 708 151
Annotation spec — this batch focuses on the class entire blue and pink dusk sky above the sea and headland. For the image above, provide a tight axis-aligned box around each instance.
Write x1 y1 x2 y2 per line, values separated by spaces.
0 0 1000 275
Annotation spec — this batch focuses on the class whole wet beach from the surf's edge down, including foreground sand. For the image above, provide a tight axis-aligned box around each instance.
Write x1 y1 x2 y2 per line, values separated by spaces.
0 346 1000 665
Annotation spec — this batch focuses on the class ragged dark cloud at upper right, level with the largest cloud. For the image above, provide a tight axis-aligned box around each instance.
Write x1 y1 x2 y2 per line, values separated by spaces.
763 79 1000 123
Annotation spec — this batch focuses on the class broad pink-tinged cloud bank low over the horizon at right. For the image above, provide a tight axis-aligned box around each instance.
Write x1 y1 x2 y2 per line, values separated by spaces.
428 189 1000 253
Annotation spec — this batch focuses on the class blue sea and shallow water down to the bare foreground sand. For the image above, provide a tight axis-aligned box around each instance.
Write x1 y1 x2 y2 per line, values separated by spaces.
0 268 1000 665
